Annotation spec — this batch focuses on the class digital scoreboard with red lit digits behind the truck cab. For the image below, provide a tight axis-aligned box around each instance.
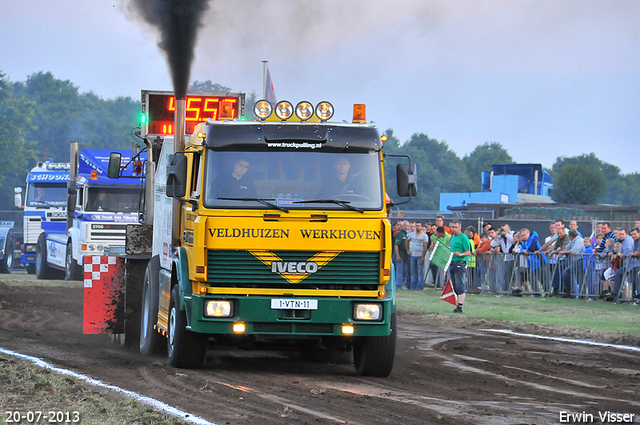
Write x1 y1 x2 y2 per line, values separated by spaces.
140 90 244 135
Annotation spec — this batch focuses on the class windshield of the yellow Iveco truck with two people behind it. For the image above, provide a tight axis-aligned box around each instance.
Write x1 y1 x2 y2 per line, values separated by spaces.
203 150 383 211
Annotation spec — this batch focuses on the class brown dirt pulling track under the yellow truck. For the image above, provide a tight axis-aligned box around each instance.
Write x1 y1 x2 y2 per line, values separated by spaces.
0 274 640 425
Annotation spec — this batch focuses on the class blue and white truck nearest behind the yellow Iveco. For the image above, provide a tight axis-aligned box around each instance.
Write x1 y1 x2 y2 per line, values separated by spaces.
35 146 146 280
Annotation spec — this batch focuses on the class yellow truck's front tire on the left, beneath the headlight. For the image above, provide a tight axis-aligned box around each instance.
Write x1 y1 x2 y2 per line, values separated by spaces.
167 285 209 369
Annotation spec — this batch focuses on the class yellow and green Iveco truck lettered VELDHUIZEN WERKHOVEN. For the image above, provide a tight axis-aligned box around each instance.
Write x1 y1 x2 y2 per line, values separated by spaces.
109 91 417 377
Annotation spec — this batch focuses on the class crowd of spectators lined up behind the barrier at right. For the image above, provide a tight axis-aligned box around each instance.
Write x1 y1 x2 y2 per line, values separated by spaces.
393 216 640 305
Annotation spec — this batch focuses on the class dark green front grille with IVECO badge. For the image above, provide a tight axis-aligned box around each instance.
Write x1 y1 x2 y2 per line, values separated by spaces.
207 250 380 290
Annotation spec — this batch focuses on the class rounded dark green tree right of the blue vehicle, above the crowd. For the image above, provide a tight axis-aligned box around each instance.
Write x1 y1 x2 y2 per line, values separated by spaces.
551 164 607 205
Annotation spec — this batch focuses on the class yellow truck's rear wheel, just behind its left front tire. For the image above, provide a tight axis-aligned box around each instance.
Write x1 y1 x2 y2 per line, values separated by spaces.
140 260 166 356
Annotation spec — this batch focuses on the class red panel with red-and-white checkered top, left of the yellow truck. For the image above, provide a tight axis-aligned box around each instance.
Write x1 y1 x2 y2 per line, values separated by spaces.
82 256 125 334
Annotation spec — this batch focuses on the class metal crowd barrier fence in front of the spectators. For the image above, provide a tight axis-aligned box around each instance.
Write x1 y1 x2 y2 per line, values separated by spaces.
398 250 640 302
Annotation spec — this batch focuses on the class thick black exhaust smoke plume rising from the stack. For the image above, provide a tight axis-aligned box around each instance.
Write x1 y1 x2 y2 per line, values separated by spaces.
129 0 209 99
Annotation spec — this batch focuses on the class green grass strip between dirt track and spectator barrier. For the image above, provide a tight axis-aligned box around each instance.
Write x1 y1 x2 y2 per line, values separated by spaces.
397 289 640 335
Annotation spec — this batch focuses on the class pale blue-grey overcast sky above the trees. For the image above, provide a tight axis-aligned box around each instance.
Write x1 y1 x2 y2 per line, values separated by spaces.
0 0 640 174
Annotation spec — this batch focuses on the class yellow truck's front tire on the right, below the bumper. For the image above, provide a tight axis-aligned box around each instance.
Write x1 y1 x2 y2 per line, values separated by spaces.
353 313 398 378
